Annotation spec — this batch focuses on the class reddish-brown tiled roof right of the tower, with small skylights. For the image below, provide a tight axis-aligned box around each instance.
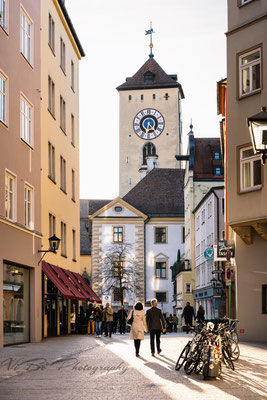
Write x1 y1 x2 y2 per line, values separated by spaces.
194 138 224 181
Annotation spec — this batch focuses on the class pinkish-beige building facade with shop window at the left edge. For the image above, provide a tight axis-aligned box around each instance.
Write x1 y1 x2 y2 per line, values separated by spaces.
0 0 42 347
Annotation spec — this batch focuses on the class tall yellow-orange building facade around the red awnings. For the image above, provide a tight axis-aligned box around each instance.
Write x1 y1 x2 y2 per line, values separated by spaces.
41 0 84 337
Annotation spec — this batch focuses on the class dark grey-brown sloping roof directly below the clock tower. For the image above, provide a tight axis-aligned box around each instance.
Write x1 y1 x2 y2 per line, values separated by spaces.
123 168 184 217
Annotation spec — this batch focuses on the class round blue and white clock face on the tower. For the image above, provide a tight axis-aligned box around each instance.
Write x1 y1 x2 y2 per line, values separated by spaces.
133 108 164 140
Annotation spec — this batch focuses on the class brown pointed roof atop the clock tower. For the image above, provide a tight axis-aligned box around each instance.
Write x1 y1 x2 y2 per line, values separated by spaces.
117 58 184 98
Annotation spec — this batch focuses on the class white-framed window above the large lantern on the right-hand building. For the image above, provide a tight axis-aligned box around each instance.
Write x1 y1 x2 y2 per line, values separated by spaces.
239 48 261 97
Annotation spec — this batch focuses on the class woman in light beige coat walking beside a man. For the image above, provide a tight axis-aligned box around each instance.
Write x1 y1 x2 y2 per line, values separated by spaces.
127 301 148 357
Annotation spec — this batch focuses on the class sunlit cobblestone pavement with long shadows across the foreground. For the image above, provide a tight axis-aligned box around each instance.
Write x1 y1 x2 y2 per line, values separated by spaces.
0 333 267 400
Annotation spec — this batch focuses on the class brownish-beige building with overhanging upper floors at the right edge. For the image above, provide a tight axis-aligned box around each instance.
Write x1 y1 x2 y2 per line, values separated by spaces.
226 0 267 341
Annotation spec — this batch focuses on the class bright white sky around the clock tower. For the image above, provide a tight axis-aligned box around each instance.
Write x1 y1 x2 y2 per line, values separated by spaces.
65 0 227 199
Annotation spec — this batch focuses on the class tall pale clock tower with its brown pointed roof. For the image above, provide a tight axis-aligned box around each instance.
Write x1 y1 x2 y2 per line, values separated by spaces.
117 52 184 197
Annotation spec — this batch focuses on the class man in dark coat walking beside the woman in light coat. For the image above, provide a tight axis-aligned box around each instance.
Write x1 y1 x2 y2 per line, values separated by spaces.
146 299 166 356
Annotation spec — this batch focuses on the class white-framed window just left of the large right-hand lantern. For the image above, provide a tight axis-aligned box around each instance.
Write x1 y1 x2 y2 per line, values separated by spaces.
240 147 262 192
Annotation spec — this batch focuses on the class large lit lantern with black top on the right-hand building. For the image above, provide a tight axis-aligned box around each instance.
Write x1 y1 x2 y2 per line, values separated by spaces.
247 107 267 164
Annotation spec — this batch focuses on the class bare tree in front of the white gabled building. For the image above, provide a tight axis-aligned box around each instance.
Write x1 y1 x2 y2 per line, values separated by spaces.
100 243 141 305
